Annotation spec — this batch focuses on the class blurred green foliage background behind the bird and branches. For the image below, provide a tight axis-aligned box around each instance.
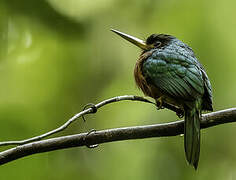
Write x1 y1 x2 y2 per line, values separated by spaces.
0 0 236 180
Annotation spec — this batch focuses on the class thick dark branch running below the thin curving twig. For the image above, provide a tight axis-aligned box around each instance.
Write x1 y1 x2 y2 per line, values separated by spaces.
0 108 236 164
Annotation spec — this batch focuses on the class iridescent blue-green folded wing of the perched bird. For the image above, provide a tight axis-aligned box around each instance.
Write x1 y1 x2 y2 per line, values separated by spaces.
143 56 204 101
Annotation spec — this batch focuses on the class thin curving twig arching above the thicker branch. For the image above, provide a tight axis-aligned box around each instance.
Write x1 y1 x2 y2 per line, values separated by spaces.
0 95 181 146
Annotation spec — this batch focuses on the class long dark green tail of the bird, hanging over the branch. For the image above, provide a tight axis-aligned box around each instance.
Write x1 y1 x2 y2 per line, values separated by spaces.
184 108 200 169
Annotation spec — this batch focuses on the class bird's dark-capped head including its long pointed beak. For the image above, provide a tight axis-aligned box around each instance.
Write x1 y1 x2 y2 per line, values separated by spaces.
111 29 177 51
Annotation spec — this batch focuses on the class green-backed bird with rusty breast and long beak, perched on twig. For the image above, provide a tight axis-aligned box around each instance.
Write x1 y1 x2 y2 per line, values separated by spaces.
111 29 213 169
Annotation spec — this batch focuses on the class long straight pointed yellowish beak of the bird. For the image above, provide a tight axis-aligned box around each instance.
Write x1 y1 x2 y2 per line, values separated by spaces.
111 29 148 50
